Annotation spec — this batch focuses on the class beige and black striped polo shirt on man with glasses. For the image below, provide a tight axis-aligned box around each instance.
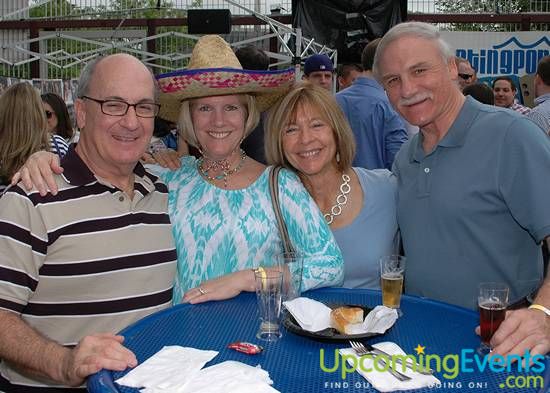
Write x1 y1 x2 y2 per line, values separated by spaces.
0 146 176 392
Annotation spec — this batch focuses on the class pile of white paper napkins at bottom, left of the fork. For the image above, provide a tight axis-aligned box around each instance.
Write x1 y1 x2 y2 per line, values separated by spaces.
115 346 277 393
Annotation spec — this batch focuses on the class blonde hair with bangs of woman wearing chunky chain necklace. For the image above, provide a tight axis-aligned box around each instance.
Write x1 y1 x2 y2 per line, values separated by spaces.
265 82 355 172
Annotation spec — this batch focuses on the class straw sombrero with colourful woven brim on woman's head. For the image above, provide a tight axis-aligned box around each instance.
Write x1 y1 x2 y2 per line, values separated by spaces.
156 35 294 122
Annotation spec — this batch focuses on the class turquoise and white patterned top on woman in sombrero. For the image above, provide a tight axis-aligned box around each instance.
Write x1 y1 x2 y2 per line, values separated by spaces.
149 156 344 303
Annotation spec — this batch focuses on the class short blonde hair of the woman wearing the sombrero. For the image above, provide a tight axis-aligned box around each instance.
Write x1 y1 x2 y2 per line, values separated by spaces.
178 94 260 148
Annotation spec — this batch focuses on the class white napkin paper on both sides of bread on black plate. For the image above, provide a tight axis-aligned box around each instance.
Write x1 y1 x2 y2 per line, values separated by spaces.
284 297 397 334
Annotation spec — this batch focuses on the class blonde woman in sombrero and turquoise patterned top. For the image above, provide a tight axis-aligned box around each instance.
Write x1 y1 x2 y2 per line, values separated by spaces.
15 36 343 303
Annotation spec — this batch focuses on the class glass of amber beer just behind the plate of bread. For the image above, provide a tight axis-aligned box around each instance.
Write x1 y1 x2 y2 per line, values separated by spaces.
380 255 406 316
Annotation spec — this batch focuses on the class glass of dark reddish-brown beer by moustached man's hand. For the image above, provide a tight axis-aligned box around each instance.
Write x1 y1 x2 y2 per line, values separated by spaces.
477 282 510 354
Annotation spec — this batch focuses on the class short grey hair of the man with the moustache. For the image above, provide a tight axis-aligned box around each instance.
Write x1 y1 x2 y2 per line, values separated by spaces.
372 22 454 81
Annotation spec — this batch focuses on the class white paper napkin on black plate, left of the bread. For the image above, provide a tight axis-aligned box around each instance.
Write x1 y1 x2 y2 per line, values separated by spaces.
283 297 331 332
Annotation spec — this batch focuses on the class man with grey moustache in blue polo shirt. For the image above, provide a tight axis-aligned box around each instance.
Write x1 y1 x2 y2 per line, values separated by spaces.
374 22 550 355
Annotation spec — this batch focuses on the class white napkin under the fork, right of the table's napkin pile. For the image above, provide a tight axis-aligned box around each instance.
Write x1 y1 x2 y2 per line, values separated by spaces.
340 342 440 392
